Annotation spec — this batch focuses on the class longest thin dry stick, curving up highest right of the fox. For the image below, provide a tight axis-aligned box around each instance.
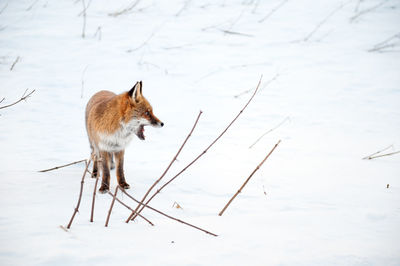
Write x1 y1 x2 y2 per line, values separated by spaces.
127 76 262 222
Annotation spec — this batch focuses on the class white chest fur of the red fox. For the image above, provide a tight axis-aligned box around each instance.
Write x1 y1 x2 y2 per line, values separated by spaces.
98 119 141 152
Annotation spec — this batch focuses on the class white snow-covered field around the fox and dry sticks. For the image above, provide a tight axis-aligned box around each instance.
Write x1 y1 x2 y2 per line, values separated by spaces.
0 0 400 265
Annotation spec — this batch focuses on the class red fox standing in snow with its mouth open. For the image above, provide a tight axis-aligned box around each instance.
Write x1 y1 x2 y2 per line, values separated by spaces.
85 81 164 193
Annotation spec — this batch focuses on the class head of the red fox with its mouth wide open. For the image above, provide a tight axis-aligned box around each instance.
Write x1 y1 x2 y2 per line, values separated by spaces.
124 81 164 140
